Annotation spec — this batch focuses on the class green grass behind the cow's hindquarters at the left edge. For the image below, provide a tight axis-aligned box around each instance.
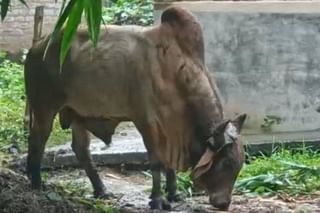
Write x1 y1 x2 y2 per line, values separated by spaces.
0 54 71 151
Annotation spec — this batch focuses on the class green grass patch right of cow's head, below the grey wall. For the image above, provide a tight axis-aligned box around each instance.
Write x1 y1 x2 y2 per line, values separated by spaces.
235 147 320 195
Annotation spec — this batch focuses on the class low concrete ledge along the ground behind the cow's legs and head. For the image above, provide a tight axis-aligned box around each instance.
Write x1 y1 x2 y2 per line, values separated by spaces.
12 131 320 169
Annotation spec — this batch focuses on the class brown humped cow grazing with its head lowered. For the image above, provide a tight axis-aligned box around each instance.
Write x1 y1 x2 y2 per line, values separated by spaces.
25 7 246 209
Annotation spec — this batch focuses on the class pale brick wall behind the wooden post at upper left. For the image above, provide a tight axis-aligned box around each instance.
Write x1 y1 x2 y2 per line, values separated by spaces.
0 0 61 52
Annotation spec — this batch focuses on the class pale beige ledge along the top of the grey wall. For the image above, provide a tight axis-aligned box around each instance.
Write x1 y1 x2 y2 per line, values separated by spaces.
154 1 320 14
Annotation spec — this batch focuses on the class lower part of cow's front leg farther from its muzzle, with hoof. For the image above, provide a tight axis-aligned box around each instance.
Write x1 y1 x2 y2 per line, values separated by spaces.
149 163 171 210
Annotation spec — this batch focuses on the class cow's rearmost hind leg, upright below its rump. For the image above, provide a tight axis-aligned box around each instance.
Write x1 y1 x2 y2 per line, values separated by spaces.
27 109 55 189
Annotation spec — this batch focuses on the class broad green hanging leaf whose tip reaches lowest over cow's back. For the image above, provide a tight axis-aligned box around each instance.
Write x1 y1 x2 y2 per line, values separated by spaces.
60 0 84 67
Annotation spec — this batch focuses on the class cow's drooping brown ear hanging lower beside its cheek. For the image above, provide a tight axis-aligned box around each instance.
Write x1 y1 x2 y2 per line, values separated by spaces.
192 148 214 179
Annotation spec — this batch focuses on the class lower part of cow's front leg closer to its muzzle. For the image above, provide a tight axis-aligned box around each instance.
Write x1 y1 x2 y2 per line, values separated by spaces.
166 169 182 202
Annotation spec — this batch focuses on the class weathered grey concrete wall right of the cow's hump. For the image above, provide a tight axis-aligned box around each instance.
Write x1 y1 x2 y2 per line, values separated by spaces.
155 2 320 139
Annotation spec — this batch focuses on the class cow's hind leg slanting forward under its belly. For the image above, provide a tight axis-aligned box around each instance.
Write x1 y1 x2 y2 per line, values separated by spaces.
72 119 112 198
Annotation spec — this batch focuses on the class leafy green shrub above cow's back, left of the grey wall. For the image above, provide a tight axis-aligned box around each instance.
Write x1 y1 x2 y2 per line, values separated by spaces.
102 0 153 26
